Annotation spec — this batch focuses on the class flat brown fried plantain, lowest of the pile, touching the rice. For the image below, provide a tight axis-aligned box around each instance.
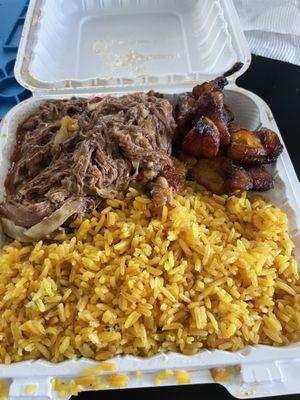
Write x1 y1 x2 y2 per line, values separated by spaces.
189 157 253 194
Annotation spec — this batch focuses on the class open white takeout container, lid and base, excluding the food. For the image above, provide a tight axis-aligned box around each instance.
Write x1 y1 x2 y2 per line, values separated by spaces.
0 0 300 399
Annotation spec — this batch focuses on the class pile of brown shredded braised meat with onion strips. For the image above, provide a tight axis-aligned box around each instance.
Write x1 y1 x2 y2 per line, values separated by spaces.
0 92 185 240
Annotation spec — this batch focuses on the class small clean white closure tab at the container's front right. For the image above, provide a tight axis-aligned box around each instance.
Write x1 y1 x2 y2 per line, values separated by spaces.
241 363 282 383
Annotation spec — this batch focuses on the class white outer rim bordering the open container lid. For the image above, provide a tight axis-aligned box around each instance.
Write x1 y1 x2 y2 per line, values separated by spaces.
14 0 251 95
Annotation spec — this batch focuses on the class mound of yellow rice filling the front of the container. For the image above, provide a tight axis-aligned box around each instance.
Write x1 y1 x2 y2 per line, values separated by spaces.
0 186 300 364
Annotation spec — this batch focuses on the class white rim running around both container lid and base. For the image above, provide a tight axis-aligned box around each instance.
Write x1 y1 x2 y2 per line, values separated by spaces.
0 0 300 399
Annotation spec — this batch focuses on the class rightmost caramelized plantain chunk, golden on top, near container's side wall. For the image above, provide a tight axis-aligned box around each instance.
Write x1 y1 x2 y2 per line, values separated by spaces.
227 127 283 165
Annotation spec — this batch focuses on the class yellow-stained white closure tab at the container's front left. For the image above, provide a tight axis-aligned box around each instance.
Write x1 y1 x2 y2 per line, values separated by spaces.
9 377 51 400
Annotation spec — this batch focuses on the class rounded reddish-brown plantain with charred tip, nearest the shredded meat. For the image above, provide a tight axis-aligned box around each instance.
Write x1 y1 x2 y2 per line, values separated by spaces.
182 117 220 158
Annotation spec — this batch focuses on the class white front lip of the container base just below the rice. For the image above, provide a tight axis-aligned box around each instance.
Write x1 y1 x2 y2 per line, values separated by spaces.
0 342 300 379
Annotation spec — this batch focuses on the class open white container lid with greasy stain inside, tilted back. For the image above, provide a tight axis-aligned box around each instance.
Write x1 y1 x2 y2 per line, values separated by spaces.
15 0 251 95
